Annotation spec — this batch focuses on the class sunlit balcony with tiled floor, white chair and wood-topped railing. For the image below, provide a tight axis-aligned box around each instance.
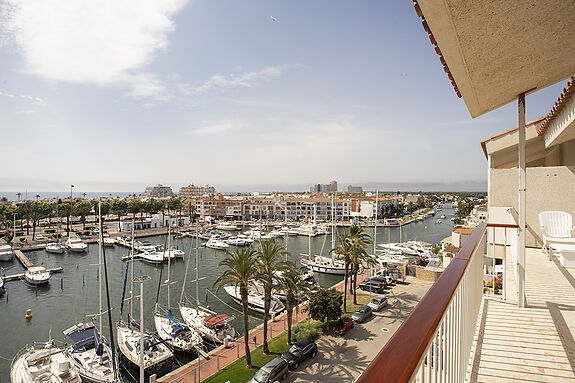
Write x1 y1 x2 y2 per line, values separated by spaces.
357 224 575 383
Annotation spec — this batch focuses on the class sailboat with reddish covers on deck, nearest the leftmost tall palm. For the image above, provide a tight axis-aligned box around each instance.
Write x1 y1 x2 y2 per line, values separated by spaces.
179 230 236 344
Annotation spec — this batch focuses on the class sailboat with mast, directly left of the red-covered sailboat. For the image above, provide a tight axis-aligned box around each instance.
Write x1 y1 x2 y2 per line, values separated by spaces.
154 218 203 353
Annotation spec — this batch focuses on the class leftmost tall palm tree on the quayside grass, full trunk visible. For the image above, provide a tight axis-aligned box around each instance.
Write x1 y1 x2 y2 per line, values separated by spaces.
212 248 257 368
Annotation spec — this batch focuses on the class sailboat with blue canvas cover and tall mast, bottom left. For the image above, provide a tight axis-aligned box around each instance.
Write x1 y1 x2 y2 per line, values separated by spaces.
64 204 118 383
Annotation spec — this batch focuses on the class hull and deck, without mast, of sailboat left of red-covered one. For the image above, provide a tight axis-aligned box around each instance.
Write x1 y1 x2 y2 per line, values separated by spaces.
154 310 203 353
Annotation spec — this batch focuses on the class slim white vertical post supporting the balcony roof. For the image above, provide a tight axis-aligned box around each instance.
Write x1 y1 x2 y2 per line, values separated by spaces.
517 93 526 307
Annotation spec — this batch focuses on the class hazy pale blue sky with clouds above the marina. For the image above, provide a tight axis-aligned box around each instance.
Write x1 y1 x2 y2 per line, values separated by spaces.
0 0 565 192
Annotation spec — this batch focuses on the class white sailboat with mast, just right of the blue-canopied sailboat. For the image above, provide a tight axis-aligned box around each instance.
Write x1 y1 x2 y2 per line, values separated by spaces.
116 219 174 381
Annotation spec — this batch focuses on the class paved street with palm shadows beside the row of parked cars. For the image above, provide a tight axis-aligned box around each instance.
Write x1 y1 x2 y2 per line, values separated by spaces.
286 277 432 382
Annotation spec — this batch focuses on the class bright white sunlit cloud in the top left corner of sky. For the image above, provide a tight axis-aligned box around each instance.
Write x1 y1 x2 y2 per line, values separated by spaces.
0 0 188 98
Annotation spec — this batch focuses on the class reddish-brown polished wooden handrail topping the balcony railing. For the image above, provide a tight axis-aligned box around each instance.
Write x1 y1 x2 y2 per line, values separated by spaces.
356 223 487 383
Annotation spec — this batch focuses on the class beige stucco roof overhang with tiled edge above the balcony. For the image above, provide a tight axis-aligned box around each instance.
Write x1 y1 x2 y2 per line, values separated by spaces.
414 0 575 117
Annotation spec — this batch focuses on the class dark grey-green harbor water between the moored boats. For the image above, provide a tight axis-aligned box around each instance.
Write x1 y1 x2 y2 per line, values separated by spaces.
0 209 454 382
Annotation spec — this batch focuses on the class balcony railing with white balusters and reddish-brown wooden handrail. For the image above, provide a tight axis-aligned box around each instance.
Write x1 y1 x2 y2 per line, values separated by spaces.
356 224 487 383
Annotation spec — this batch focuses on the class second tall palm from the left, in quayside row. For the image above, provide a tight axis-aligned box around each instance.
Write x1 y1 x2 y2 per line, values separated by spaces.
257 240 289 354
